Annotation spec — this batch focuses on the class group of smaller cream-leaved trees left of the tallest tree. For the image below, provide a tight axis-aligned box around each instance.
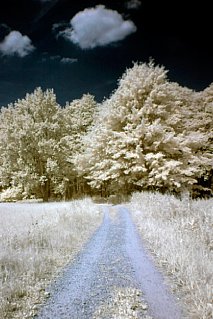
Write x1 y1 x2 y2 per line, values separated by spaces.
0 88 95 201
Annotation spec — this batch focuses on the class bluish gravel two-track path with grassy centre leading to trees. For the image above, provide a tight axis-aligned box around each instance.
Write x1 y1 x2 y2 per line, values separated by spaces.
36 205 183 319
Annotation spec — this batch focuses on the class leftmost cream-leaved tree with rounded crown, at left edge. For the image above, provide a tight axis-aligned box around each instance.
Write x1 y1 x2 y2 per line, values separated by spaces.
0 88 61 201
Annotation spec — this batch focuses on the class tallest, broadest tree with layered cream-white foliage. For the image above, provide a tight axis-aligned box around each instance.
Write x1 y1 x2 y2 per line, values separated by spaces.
78 61 212 192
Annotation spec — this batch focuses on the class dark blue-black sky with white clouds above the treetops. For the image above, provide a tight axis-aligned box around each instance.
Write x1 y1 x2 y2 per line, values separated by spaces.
0 0 213 106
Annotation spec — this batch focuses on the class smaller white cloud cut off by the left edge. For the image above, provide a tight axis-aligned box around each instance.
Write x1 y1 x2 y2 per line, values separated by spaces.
0 31 35 57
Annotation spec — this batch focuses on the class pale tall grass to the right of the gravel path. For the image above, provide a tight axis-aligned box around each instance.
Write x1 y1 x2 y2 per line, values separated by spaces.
127 192 213 319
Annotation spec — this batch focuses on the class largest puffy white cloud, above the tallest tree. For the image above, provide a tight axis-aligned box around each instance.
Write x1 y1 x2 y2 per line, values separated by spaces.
60 5 137 49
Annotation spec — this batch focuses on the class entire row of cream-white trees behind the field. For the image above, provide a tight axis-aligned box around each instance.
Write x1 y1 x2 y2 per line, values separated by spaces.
0 61 213 201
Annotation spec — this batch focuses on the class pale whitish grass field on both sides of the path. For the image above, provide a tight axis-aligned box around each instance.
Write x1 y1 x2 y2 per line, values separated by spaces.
0 192 213 319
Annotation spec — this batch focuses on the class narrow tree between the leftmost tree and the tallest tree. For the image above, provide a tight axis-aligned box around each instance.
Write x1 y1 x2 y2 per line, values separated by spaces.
56 94 97 198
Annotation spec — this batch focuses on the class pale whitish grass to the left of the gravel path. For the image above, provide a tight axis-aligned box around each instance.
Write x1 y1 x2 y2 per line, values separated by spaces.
0 198 102 319
